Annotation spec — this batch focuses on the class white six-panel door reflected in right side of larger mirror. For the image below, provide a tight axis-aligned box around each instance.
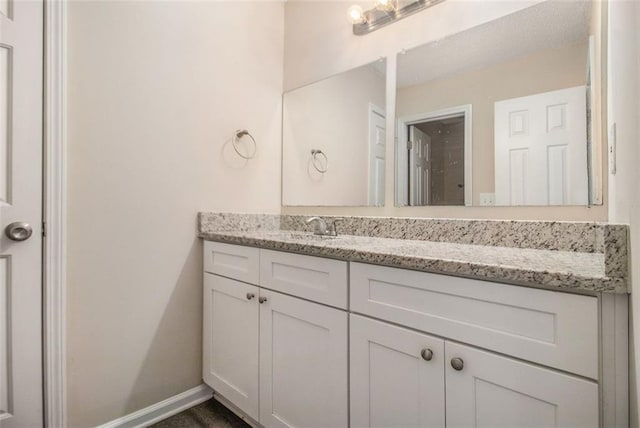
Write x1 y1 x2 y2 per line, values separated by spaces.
495 86 589 205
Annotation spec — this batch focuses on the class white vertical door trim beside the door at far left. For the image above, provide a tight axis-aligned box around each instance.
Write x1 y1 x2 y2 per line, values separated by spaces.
42 0 67 427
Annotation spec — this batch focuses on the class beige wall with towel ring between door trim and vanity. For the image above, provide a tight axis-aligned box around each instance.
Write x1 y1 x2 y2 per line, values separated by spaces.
68 1 284 427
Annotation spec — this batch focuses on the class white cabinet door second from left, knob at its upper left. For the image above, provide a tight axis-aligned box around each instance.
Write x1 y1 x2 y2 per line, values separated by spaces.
260 289 348 428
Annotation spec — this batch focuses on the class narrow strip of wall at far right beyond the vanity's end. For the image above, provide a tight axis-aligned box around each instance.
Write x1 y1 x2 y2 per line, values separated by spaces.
608 0 640 427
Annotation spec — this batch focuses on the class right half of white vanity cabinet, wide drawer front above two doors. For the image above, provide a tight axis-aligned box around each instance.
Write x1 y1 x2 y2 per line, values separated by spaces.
350 263 600 428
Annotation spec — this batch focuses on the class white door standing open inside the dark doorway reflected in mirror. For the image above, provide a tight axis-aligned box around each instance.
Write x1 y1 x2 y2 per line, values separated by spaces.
409 125 431 206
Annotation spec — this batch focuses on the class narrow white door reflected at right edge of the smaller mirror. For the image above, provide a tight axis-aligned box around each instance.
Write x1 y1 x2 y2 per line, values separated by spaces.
369 104 387 206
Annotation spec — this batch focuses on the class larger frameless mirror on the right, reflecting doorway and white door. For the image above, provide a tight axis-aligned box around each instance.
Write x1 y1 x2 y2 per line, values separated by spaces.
395 0 606 206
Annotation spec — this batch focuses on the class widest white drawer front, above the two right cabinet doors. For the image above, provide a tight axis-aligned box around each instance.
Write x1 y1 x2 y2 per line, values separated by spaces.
351 263 598 379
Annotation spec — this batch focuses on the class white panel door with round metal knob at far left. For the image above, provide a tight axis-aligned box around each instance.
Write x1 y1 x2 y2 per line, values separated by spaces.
0 0 43 428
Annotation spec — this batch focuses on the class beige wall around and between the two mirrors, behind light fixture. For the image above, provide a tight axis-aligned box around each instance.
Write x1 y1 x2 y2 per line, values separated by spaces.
283 0 607 220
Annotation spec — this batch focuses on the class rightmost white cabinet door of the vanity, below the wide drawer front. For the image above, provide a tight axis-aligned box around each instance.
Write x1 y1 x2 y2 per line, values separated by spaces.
445 342 599 428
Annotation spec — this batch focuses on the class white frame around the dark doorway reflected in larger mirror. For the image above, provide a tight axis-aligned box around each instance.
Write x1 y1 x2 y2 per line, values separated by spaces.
395 104 473 207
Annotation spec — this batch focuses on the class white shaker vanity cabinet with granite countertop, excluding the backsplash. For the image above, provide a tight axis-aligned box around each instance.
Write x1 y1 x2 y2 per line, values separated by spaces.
200 215 628 427
